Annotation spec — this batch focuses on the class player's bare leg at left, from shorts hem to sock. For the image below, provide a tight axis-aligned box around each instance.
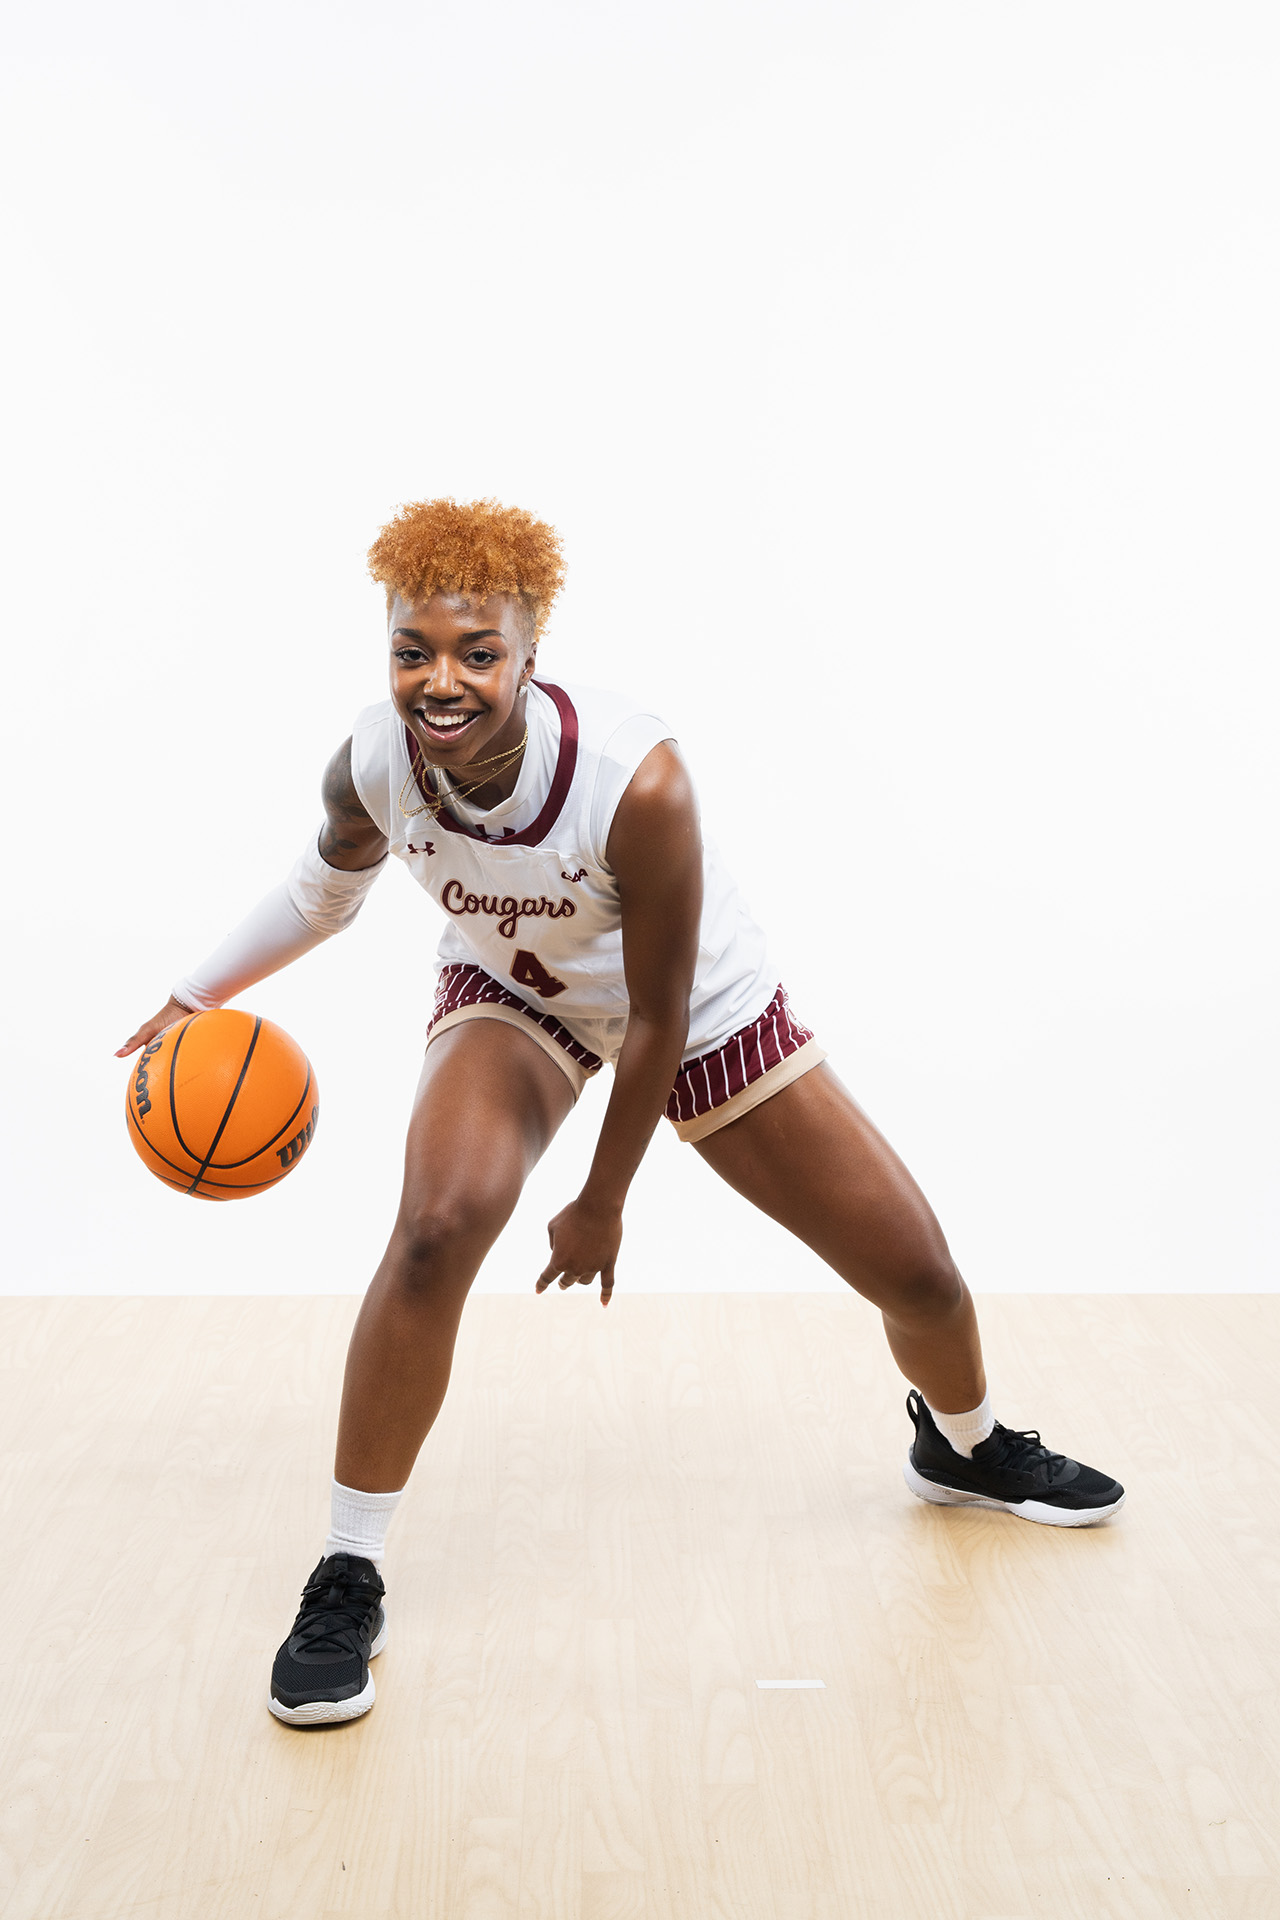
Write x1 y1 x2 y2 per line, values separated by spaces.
334 1020 574 1494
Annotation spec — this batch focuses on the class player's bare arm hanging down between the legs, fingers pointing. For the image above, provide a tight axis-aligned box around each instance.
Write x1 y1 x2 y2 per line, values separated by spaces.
537 741 702 1306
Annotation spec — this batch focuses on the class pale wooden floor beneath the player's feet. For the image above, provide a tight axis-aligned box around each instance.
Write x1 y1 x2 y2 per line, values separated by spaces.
0 1294 1280 1920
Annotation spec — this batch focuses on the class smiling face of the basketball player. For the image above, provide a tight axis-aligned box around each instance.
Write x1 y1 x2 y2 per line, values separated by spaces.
390 593 537 779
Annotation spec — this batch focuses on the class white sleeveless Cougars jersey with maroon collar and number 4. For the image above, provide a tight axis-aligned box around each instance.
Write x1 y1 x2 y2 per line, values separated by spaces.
351 682 777 1060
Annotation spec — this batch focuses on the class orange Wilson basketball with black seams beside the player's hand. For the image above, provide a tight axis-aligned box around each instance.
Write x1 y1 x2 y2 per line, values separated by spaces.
125 1008 320 1200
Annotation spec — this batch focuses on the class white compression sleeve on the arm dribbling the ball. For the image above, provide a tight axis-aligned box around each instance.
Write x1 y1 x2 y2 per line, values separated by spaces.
173 841 386 1014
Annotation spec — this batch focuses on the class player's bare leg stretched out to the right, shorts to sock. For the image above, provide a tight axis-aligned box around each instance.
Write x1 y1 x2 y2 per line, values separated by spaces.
697 1064 986 1413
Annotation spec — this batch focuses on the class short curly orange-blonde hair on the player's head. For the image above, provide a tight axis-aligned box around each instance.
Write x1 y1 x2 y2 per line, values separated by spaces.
368 499 564 639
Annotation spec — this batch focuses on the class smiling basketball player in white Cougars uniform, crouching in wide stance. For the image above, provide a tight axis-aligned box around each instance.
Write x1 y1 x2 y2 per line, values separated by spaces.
121 499 1125 1726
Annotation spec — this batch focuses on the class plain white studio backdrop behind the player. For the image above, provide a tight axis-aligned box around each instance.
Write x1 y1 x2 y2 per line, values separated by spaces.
0 0 1280 1311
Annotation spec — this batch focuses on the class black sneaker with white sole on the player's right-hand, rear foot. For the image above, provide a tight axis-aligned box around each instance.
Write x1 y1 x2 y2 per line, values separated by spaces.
902 1388 1125 1526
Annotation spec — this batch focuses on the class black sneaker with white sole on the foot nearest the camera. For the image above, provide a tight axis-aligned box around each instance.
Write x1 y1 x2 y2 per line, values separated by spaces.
267 1553 386 1726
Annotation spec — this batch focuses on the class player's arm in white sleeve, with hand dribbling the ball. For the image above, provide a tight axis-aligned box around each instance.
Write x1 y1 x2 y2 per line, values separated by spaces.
117 739 388 1060
